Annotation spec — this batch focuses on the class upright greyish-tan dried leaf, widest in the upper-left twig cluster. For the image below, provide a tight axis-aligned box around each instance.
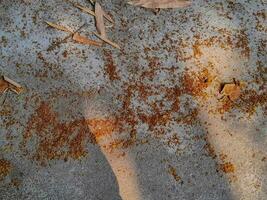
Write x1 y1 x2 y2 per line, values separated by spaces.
95 2 107 38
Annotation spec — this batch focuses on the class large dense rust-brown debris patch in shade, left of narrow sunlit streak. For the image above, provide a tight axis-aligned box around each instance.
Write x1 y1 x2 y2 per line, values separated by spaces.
21 102 95 165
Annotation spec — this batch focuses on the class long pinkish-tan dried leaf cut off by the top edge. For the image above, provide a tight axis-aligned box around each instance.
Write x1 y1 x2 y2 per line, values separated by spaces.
128 0 191 8
